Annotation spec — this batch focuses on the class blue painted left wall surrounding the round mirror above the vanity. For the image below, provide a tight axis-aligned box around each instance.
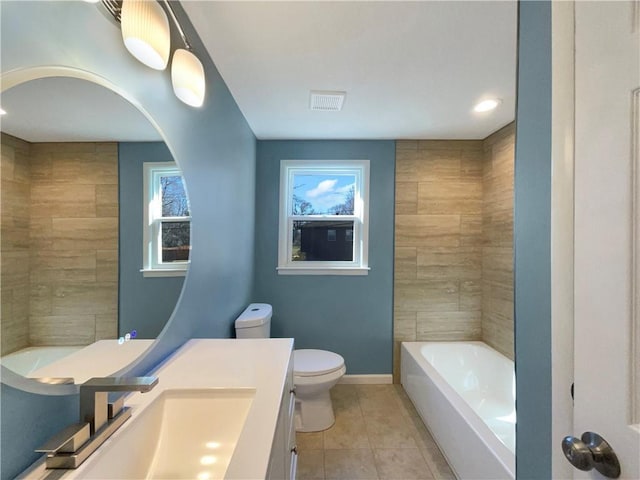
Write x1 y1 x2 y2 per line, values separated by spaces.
0 0 256 479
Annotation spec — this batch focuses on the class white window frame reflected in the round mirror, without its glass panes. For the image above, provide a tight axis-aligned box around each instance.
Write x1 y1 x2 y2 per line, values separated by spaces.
140 162 191 277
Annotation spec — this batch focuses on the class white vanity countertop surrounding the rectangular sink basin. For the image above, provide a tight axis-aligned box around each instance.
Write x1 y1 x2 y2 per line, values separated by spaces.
22 338 293 480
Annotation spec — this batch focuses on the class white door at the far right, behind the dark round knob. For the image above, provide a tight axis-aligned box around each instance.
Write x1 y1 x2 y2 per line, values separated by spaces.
568 1 640 479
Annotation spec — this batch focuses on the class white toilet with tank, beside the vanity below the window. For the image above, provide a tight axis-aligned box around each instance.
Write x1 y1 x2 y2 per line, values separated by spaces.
235 303 347 432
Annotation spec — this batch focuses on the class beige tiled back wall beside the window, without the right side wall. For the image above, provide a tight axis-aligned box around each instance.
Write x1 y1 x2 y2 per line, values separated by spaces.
394 141 484 381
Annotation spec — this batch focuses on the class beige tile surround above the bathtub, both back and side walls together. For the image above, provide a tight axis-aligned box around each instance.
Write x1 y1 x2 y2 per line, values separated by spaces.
393 125 514 381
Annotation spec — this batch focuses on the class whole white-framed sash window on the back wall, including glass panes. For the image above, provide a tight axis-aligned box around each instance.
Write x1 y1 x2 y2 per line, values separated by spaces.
278 160 369 275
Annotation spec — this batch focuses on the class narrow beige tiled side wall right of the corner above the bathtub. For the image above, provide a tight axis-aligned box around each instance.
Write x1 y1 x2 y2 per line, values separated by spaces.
482 124 515 359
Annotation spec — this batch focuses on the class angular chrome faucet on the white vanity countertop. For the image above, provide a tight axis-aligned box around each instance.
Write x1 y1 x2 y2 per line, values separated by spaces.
36 377 158 468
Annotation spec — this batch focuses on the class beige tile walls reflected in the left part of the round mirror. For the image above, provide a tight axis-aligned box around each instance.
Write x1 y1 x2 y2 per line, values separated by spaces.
0 134 118 354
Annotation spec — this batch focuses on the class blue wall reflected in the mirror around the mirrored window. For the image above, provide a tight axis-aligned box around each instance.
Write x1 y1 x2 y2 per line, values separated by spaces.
118 142 184 338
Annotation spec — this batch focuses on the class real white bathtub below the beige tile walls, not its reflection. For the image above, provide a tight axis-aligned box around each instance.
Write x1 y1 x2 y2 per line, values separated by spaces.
401 342 516 480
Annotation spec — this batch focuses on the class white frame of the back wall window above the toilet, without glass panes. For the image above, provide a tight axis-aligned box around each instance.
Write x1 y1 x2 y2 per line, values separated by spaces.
277 160 370 275
